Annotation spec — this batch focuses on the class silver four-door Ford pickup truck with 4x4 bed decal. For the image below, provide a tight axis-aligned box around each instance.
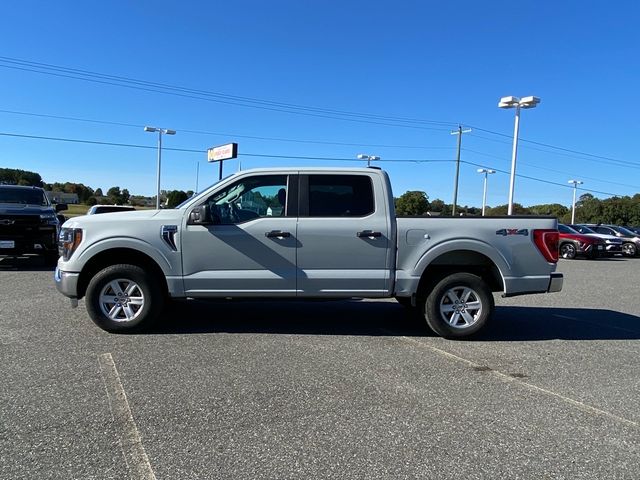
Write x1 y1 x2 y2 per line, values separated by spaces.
55 168 563 337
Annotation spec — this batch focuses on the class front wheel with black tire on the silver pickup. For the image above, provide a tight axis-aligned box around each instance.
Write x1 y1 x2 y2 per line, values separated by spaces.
86 264 165 333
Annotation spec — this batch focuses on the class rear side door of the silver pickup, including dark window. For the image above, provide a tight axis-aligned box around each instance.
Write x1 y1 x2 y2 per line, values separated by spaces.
297 172 394 297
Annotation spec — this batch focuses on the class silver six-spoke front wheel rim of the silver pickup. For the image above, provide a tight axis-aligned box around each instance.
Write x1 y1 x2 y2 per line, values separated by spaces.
100 278 144 322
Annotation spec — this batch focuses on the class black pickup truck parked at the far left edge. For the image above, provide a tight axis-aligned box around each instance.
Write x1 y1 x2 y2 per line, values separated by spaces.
0 185 67 264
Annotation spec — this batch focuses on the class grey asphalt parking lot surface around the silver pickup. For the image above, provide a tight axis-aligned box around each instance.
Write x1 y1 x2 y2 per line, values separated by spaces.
0 259 640 479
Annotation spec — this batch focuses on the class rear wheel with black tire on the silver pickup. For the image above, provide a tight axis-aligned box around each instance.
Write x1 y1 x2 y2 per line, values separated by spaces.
423 273 495 338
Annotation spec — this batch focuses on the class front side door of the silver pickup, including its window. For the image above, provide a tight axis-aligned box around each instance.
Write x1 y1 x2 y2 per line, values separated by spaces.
181 174 298 297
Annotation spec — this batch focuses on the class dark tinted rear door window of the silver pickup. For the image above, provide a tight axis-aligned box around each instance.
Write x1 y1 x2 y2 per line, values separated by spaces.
309 175 375 217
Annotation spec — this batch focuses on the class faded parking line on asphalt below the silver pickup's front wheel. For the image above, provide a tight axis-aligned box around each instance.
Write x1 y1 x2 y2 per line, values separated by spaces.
98 353 156 480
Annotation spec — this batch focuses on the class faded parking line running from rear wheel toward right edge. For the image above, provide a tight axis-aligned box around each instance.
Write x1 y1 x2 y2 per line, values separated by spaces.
381 329 638 428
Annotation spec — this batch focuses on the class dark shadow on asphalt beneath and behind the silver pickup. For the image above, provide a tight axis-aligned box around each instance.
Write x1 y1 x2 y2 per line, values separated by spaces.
148 300 640 342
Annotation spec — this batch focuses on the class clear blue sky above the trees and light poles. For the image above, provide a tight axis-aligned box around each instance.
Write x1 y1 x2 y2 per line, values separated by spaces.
0 0 640 206
